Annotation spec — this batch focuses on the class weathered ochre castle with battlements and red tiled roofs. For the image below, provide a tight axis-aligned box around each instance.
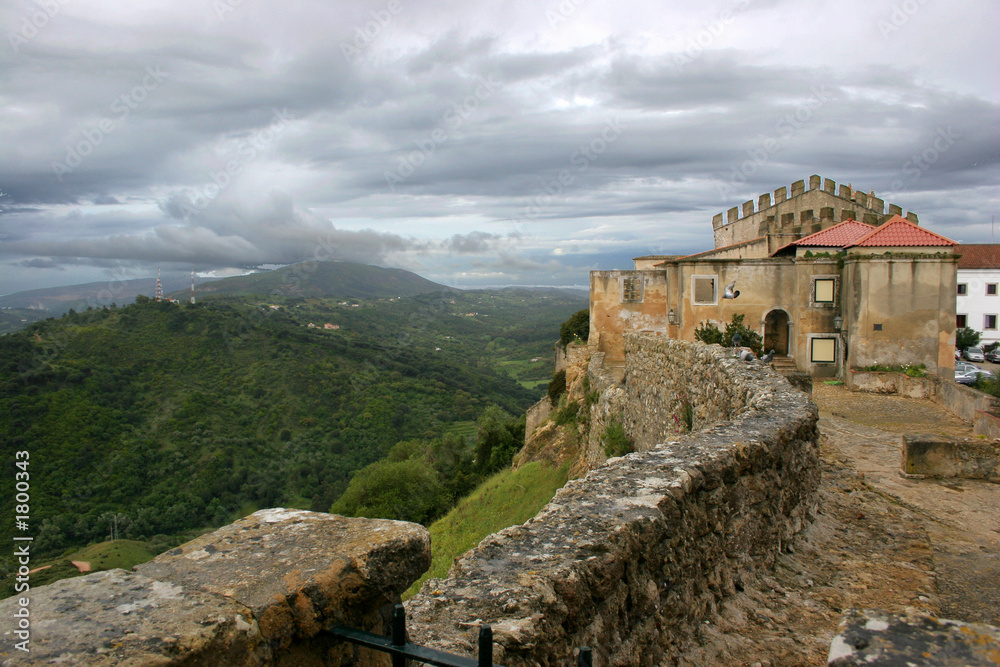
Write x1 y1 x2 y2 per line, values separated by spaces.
589 175 957 381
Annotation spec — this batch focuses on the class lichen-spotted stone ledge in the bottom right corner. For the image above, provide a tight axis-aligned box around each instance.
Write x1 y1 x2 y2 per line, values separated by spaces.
828 609 1000 667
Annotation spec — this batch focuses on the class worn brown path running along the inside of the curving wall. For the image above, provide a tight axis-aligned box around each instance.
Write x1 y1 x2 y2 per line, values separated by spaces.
679 384 1000 667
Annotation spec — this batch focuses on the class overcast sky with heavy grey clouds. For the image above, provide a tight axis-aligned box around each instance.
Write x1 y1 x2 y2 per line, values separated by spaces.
0 0 1000 294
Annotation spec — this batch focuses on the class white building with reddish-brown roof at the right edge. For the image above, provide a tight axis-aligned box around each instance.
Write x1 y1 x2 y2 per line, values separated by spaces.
955 243 1000 344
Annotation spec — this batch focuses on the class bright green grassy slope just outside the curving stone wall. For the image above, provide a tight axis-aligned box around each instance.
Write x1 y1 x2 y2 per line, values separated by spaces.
403 462 568 599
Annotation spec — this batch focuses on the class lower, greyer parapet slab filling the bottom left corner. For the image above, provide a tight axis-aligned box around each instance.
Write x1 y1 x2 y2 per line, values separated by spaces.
0 570 264 667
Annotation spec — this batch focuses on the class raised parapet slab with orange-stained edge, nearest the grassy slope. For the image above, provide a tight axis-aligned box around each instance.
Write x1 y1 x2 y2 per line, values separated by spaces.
135 508 430 647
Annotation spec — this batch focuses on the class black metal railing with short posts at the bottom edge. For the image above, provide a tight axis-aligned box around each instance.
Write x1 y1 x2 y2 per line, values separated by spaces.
327 604 593 667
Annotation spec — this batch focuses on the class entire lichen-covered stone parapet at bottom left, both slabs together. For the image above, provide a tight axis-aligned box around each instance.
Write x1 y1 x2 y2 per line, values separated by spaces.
0 508 430 667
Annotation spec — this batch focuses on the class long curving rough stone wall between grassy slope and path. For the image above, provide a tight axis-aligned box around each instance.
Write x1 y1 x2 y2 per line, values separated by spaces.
407 334 819 667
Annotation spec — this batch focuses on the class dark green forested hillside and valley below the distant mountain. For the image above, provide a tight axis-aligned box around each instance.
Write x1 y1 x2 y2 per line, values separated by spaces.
0 290 585 554
